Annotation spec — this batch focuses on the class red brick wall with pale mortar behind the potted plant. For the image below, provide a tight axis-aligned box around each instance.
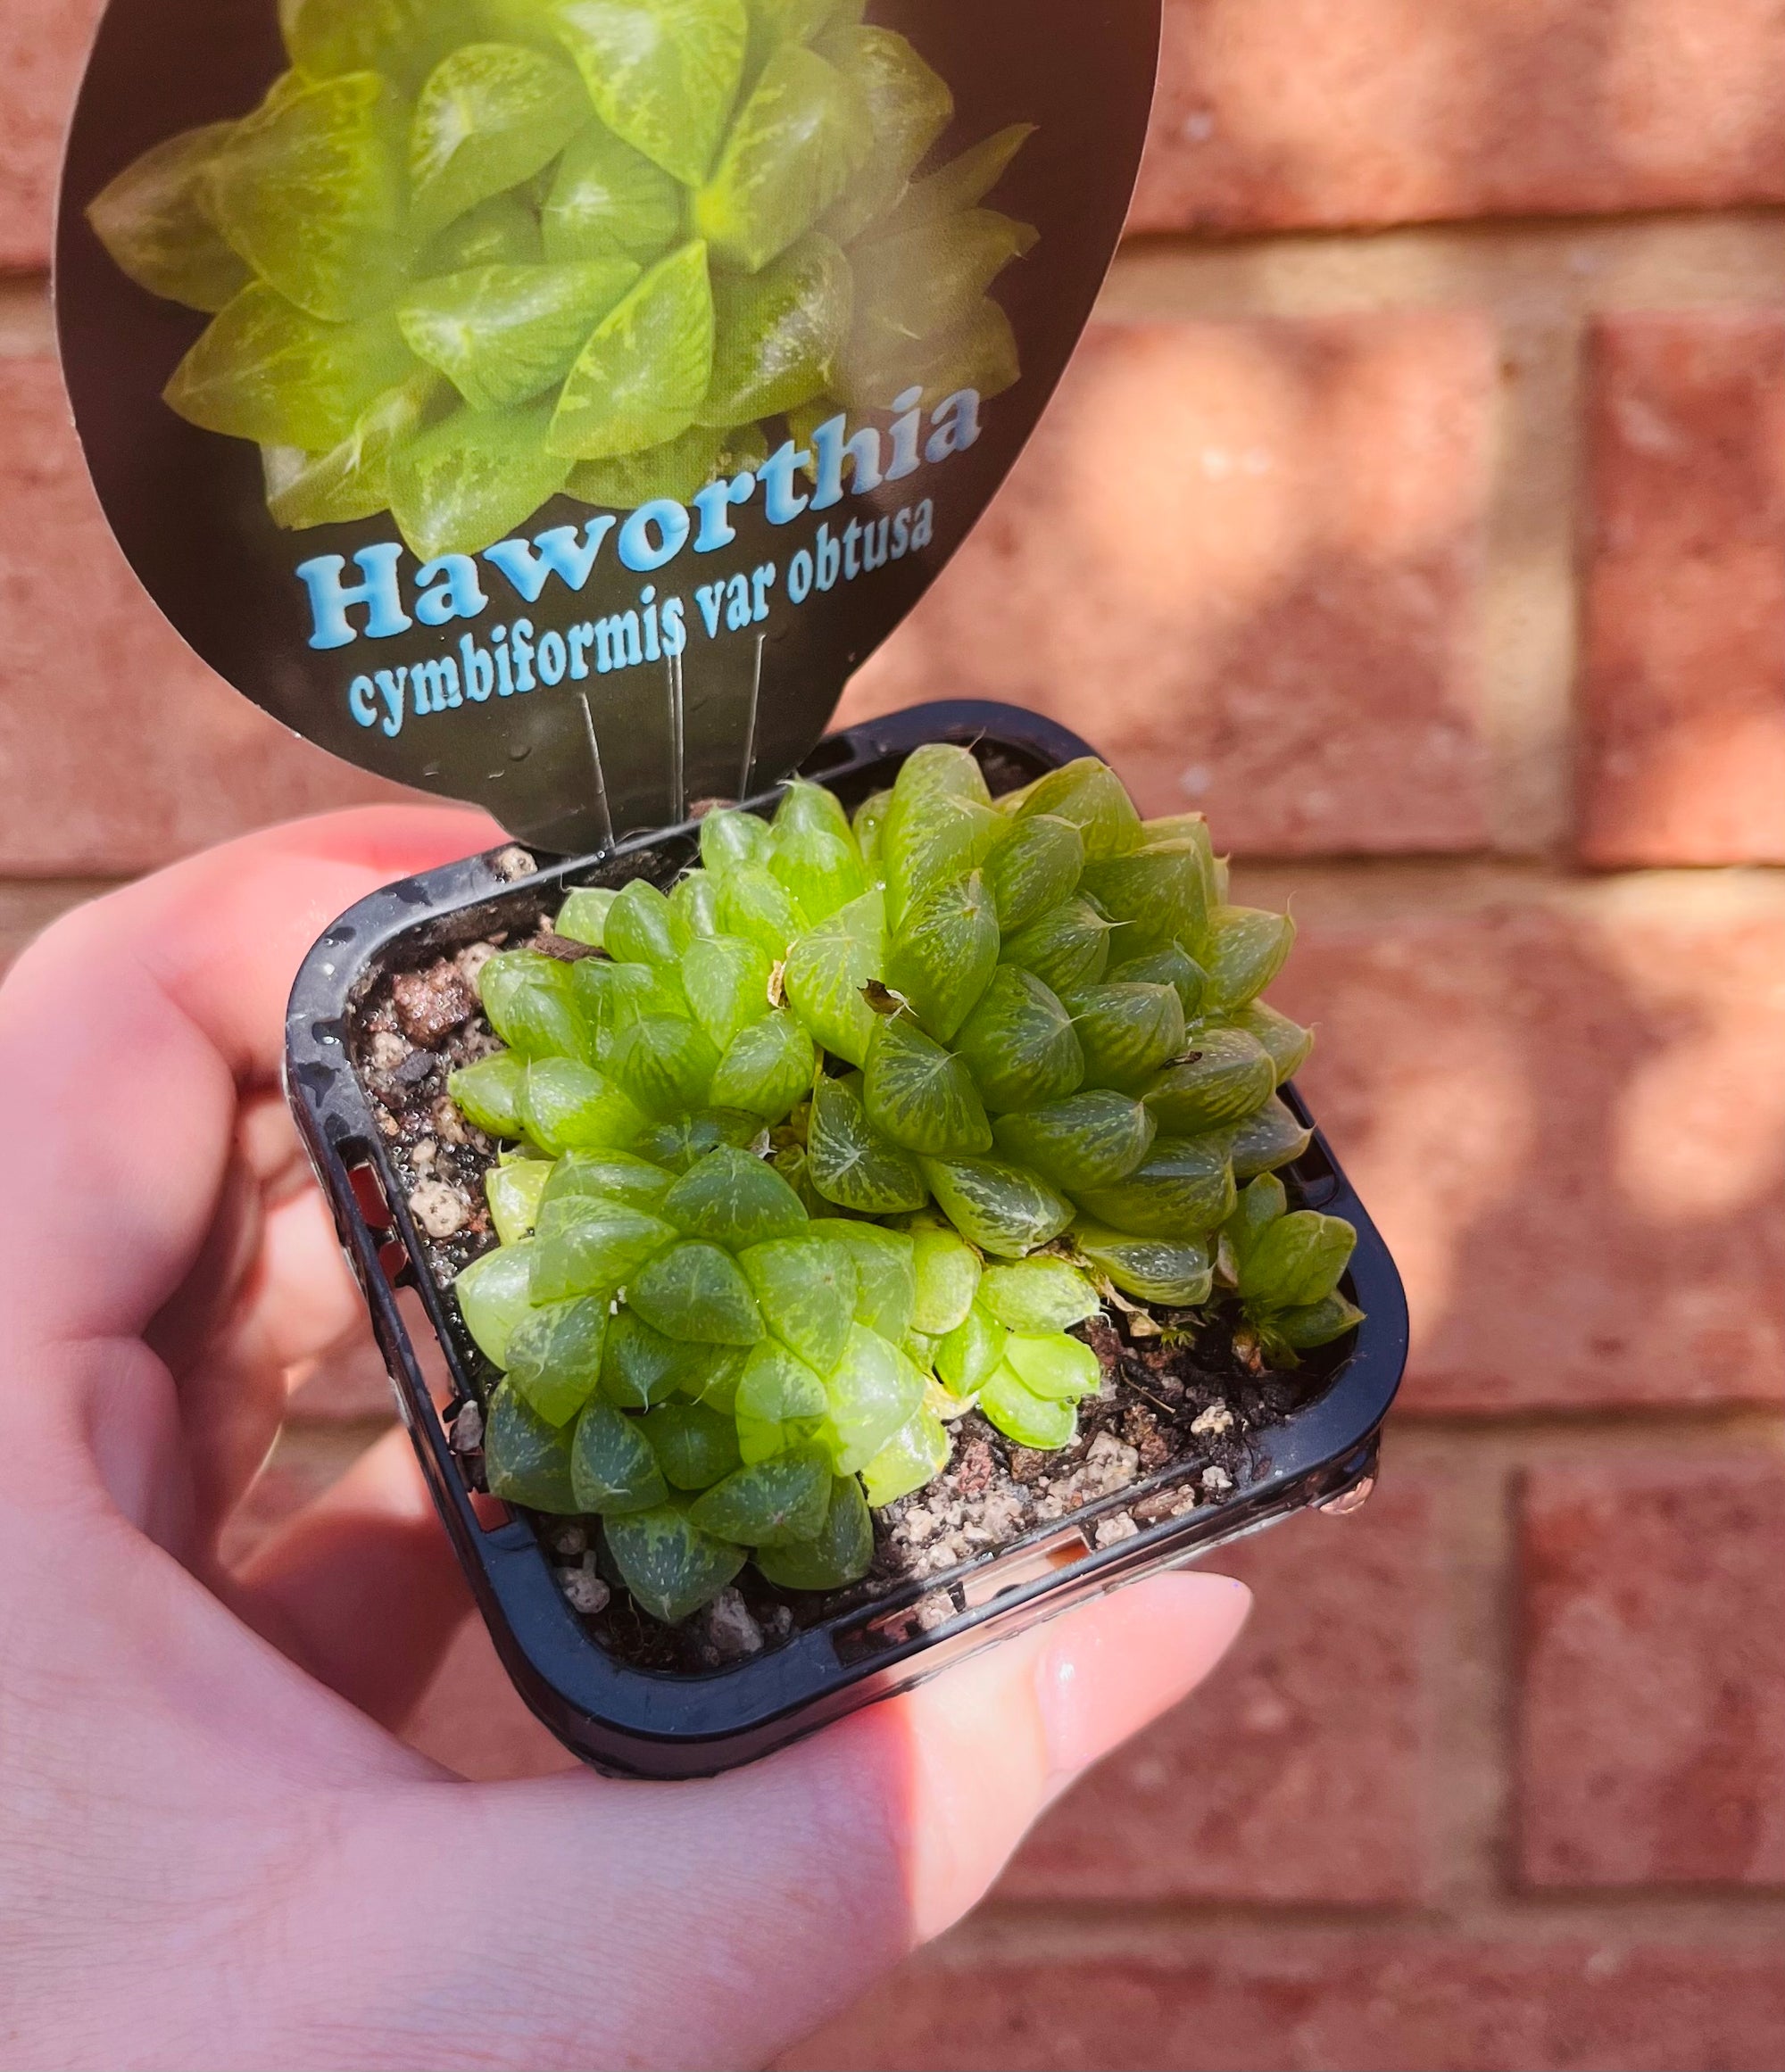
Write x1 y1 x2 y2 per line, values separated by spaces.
0 0 1785 2072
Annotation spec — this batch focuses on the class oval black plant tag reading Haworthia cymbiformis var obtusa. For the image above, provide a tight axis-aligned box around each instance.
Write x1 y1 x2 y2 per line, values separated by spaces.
56 0 1161 851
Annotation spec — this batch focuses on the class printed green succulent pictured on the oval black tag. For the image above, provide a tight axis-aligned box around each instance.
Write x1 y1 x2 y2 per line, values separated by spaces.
89 0 1036 559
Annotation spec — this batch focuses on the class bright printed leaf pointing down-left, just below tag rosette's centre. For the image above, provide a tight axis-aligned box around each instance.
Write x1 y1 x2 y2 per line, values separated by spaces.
547 238 713 460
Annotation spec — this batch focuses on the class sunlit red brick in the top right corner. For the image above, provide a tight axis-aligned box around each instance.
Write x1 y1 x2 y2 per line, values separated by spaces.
1134 0 1785 230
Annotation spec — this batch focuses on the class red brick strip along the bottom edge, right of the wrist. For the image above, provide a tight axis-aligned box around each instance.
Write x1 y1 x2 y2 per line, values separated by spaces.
779 1927 1785 2072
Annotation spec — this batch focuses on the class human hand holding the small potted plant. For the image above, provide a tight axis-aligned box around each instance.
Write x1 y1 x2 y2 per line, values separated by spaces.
0 808 1248 2068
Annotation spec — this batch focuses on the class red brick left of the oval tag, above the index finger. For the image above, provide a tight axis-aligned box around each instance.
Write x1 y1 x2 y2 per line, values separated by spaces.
0 361 406 876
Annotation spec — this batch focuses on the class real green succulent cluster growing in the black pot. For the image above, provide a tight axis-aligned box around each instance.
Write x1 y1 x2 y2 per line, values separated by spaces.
441 746 1360 1620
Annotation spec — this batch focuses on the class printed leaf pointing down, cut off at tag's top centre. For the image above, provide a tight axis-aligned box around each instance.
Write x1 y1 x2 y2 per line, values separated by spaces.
550 0 746 186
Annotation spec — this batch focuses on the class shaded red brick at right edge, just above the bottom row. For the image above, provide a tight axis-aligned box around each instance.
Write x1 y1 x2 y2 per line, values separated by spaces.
1520 1456 1785 1886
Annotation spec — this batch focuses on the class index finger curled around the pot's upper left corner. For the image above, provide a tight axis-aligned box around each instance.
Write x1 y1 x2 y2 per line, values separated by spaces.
0 806 502 1376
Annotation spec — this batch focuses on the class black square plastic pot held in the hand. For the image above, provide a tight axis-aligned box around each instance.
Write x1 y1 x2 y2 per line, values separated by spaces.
286 704 1407 1778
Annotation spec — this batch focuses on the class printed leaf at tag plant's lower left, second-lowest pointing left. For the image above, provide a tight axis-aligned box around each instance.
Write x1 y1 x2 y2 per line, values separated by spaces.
162 279 417 454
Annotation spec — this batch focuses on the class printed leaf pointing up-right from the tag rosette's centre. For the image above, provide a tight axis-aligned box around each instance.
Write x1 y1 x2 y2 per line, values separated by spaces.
694 44 873 274
